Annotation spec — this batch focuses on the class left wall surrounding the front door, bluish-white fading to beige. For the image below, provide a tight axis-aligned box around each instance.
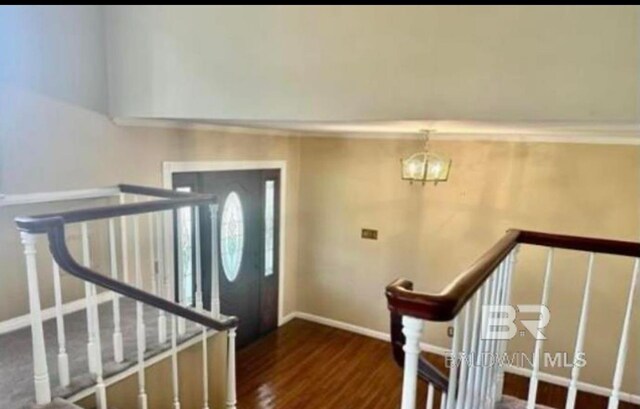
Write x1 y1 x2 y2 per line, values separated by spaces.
0 87 300 320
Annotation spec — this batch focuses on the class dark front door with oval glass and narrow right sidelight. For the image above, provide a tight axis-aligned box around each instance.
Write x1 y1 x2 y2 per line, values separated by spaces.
173 170 280 347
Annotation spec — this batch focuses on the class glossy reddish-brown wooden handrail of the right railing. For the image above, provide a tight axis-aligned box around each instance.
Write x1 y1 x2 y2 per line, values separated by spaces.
385 229 640 321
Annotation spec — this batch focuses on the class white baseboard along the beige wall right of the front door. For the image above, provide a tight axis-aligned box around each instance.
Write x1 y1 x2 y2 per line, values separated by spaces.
290 311 640 405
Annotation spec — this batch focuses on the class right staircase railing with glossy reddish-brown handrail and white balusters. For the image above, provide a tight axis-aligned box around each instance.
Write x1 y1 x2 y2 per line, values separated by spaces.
386 230 640 409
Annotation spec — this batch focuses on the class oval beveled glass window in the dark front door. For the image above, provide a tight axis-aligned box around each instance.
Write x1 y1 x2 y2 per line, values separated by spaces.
220 192 244 281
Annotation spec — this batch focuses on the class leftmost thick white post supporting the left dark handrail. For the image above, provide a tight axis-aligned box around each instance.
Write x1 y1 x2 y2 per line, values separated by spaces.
20 232 51 405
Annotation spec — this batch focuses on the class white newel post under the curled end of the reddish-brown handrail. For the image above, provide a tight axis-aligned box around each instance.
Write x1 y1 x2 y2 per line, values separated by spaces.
401 316 423 409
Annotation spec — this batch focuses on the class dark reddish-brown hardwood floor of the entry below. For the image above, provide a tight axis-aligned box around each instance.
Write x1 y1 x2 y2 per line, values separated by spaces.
237 319 638 409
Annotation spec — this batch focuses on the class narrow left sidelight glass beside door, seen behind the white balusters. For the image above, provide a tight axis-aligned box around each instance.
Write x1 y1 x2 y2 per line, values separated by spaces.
176 186 193 305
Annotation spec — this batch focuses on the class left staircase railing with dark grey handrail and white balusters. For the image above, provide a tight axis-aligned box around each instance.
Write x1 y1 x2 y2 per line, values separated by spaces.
16 185 238 409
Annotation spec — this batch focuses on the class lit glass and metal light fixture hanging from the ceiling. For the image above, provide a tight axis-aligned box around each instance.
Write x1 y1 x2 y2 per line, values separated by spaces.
401 130 451 185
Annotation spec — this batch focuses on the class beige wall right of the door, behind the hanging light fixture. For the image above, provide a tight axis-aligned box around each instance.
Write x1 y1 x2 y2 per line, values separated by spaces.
298 139 640 393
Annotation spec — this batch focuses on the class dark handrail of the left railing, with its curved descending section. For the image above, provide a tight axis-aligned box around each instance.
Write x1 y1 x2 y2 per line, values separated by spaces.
15 185 238 331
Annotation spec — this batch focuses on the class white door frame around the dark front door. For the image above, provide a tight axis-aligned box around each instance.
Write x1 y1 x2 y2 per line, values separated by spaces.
162 160 287 326
